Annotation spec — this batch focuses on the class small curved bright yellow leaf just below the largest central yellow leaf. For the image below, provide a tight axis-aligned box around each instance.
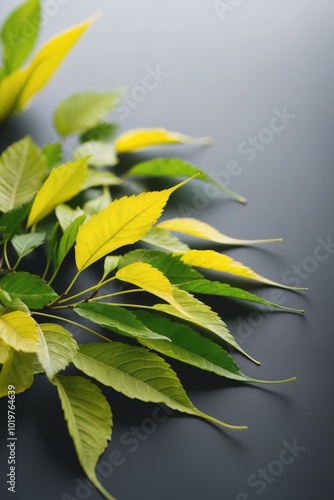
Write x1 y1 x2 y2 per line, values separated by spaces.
116 262 175 304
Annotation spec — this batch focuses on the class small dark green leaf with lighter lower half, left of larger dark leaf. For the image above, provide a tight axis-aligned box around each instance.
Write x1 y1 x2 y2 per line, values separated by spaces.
74 302 170 339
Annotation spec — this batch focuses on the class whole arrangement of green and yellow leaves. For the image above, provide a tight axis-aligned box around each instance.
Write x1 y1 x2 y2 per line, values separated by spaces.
0 0 302 499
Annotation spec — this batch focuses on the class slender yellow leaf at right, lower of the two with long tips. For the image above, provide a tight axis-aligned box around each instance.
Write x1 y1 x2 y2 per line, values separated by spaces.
181 250 297 290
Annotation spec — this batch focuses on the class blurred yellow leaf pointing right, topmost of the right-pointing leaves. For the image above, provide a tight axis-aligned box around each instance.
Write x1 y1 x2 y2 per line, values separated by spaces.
115 128 211 153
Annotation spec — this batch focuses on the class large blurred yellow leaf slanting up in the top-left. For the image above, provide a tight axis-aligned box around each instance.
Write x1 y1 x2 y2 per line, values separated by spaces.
0 16 96 121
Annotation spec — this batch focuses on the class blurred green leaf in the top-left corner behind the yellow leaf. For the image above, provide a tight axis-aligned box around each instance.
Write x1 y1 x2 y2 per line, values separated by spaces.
1 0 41 74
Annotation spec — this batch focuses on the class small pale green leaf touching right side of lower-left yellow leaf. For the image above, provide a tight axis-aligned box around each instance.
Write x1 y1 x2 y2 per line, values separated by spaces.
37 323 78 380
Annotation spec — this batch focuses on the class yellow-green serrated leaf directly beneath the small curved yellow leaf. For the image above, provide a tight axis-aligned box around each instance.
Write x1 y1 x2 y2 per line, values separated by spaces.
153 288 259 364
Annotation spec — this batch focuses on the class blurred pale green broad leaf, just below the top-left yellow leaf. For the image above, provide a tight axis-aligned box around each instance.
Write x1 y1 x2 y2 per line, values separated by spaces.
54 90 122 136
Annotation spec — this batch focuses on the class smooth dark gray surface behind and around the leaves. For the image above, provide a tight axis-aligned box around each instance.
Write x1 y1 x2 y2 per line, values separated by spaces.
0 0 334 500
